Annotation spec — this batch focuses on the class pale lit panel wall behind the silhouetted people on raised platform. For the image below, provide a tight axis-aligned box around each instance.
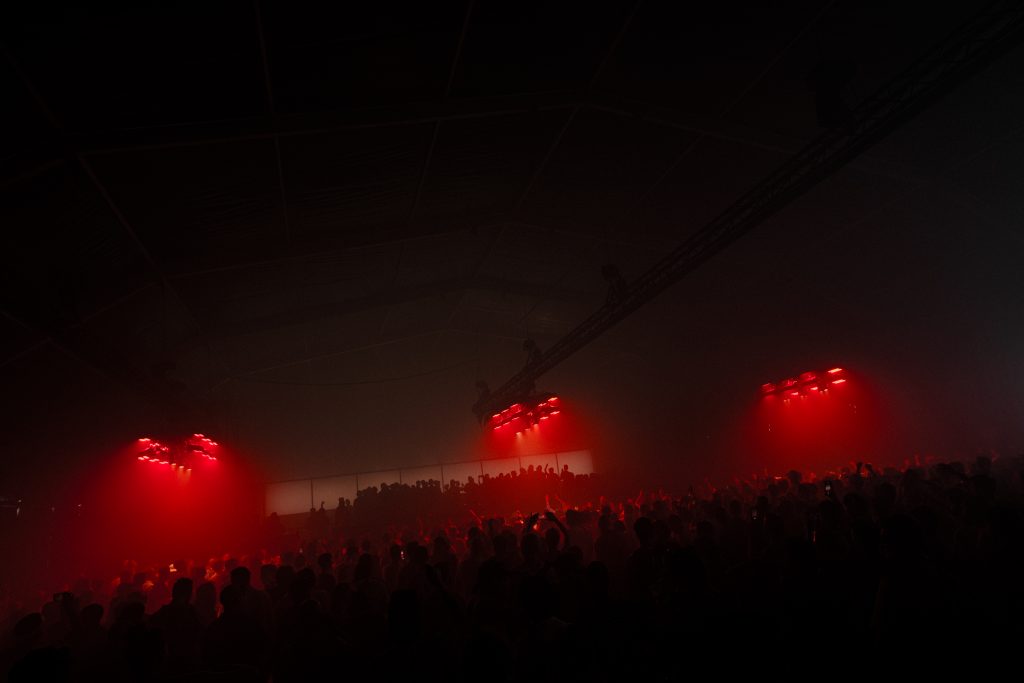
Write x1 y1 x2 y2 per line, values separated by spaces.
265 451 594 515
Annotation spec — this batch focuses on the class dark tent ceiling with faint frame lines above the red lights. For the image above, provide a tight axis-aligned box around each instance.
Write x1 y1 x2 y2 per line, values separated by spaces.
0 1 1024 491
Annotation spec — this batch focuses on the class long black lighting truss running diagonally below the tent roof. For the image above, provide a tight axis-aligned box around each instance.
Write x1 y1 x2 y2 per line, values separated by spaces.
474 3 1024 420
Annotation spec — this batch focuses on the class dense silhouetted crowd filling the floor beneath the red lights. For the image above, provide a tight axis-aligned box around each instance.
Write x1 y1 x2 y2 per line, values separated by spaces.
2 457 1024 681
